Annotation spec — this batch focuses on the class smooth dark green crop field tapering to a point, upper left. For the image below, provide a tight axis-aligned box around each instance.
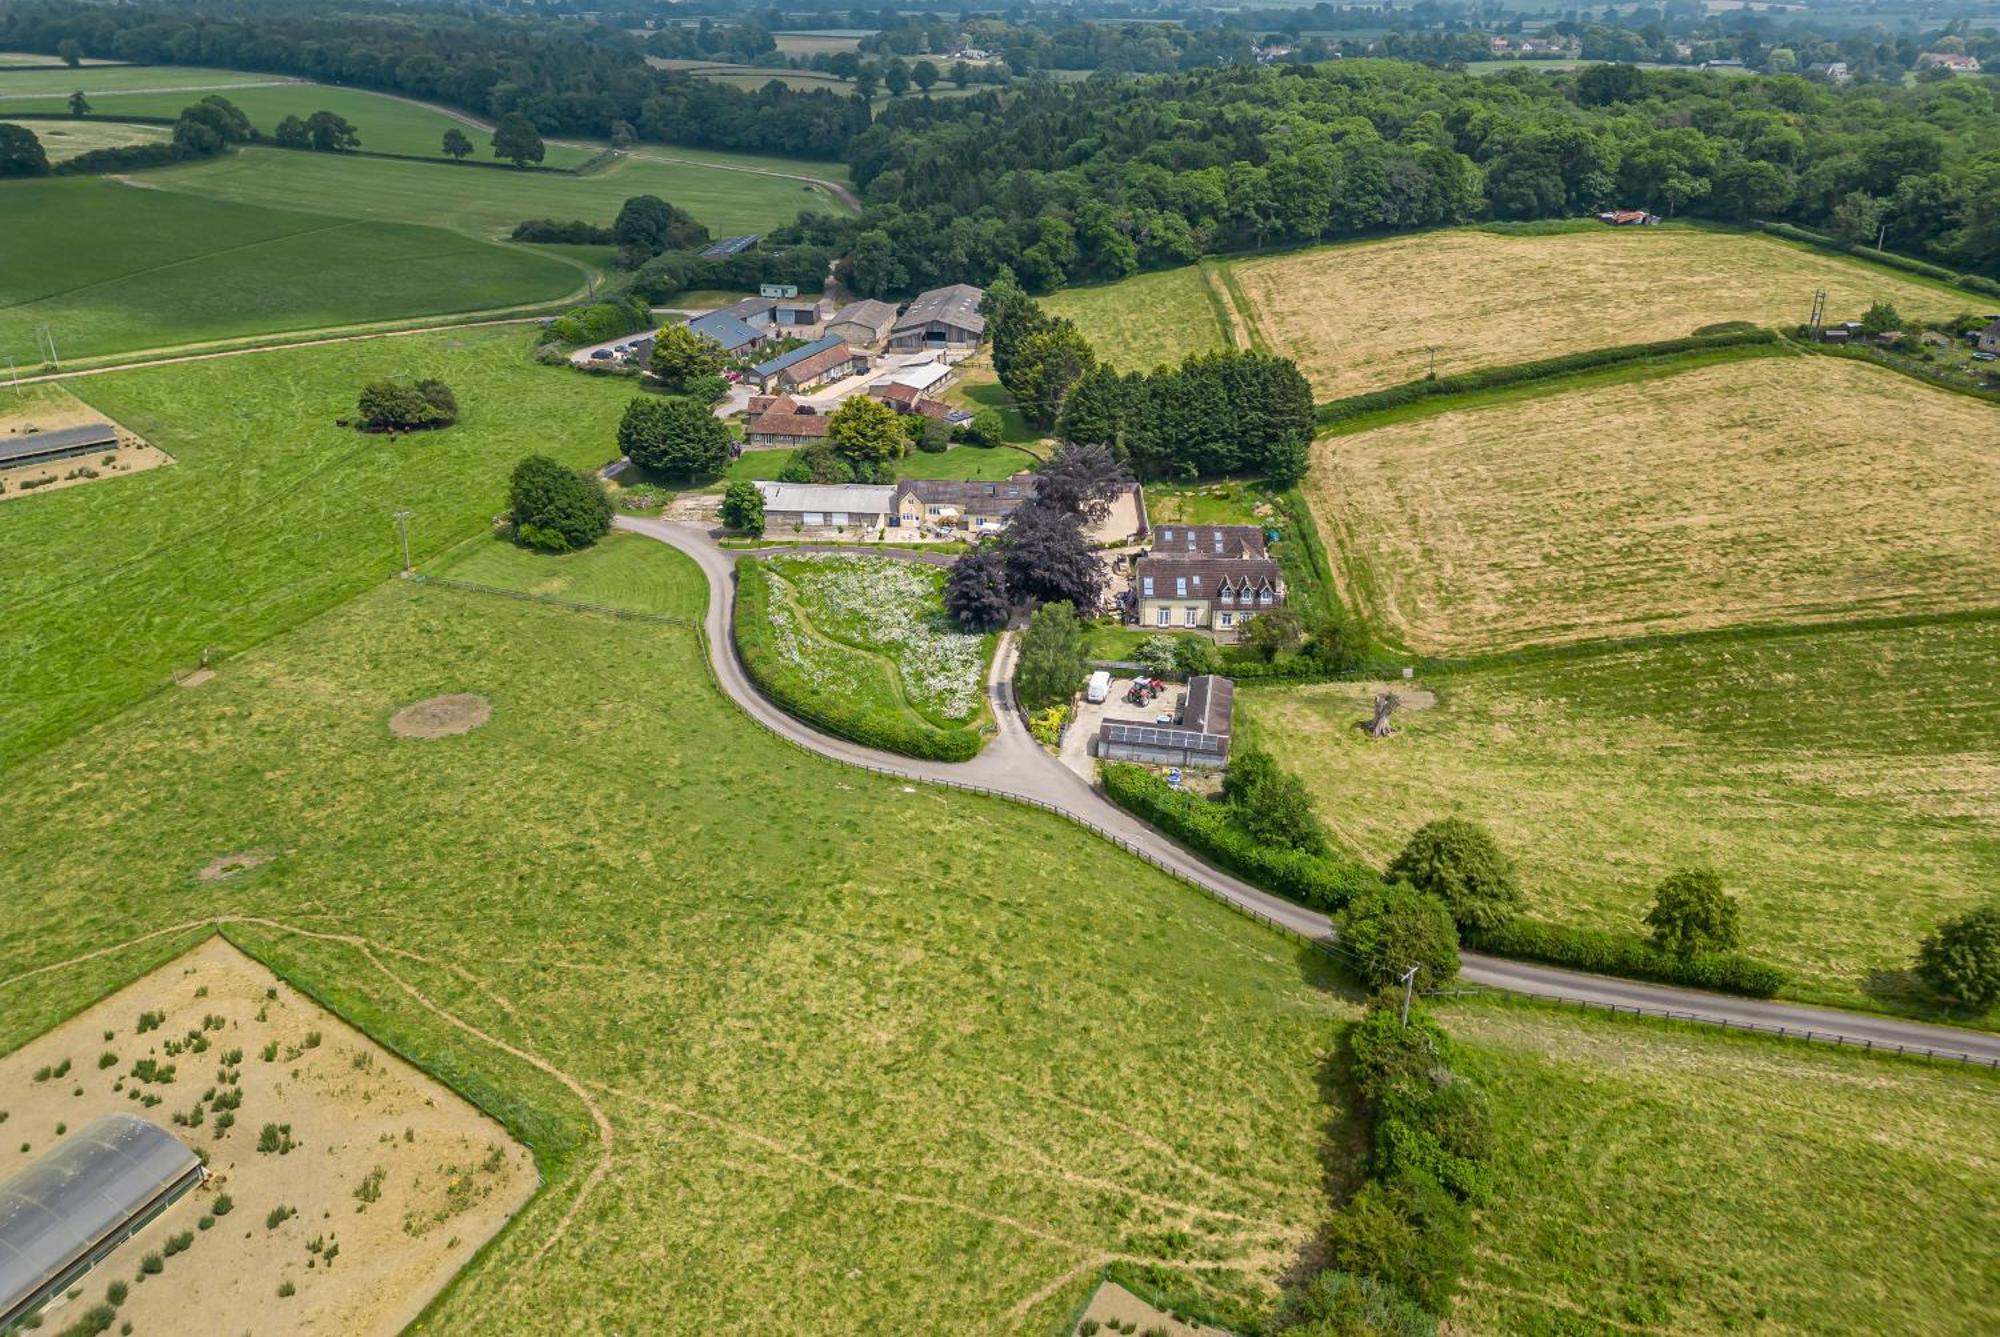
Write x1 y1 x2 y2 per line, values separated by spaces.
0 180 582 368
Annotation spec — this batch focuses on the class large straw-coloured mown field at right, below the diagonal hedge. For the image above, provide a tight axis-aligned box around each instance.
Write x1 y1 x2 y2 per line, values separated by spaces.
1306 356 2000 654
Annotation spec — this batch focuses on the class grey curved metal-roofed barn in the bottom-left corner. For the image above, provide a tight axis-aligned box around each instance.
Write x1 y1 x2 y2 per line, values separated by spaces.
0 1115 206 1329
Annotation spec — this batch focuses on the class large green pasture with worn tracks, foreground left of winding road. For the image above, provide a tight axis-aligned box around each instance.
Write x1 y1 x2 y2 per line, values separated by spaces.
0 568 1352 1333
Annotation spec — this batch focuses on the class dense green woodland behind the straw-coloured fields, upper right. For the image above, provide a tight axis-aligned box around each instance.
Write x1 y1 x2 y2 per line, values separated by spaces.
850 62 2000 292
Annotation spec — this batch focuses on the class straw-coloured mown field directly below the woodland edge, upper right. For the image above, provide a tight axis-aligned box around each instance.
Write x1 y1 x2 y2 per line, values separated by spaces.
1228 228 1960 400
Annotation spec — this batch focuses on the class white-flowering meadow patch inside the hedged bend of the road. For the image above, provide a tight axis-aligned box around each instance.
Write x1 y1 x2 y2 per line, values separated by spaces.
772 552 986 723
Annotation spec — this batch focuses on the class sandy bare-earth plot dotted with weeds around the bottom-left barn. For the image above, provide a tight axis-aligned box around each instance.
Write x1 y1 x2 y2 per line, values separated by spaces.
0 937 536 1335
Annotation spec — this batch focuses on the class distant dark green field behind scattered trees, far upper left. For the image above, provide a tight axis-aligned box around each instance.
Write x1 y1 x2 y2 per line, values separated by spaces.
0 86 596 168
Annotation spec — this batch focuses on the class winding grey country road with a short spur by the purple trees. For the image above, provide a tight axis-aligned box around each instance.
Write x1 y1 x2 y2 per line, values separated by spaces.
614 516 2000 1065
